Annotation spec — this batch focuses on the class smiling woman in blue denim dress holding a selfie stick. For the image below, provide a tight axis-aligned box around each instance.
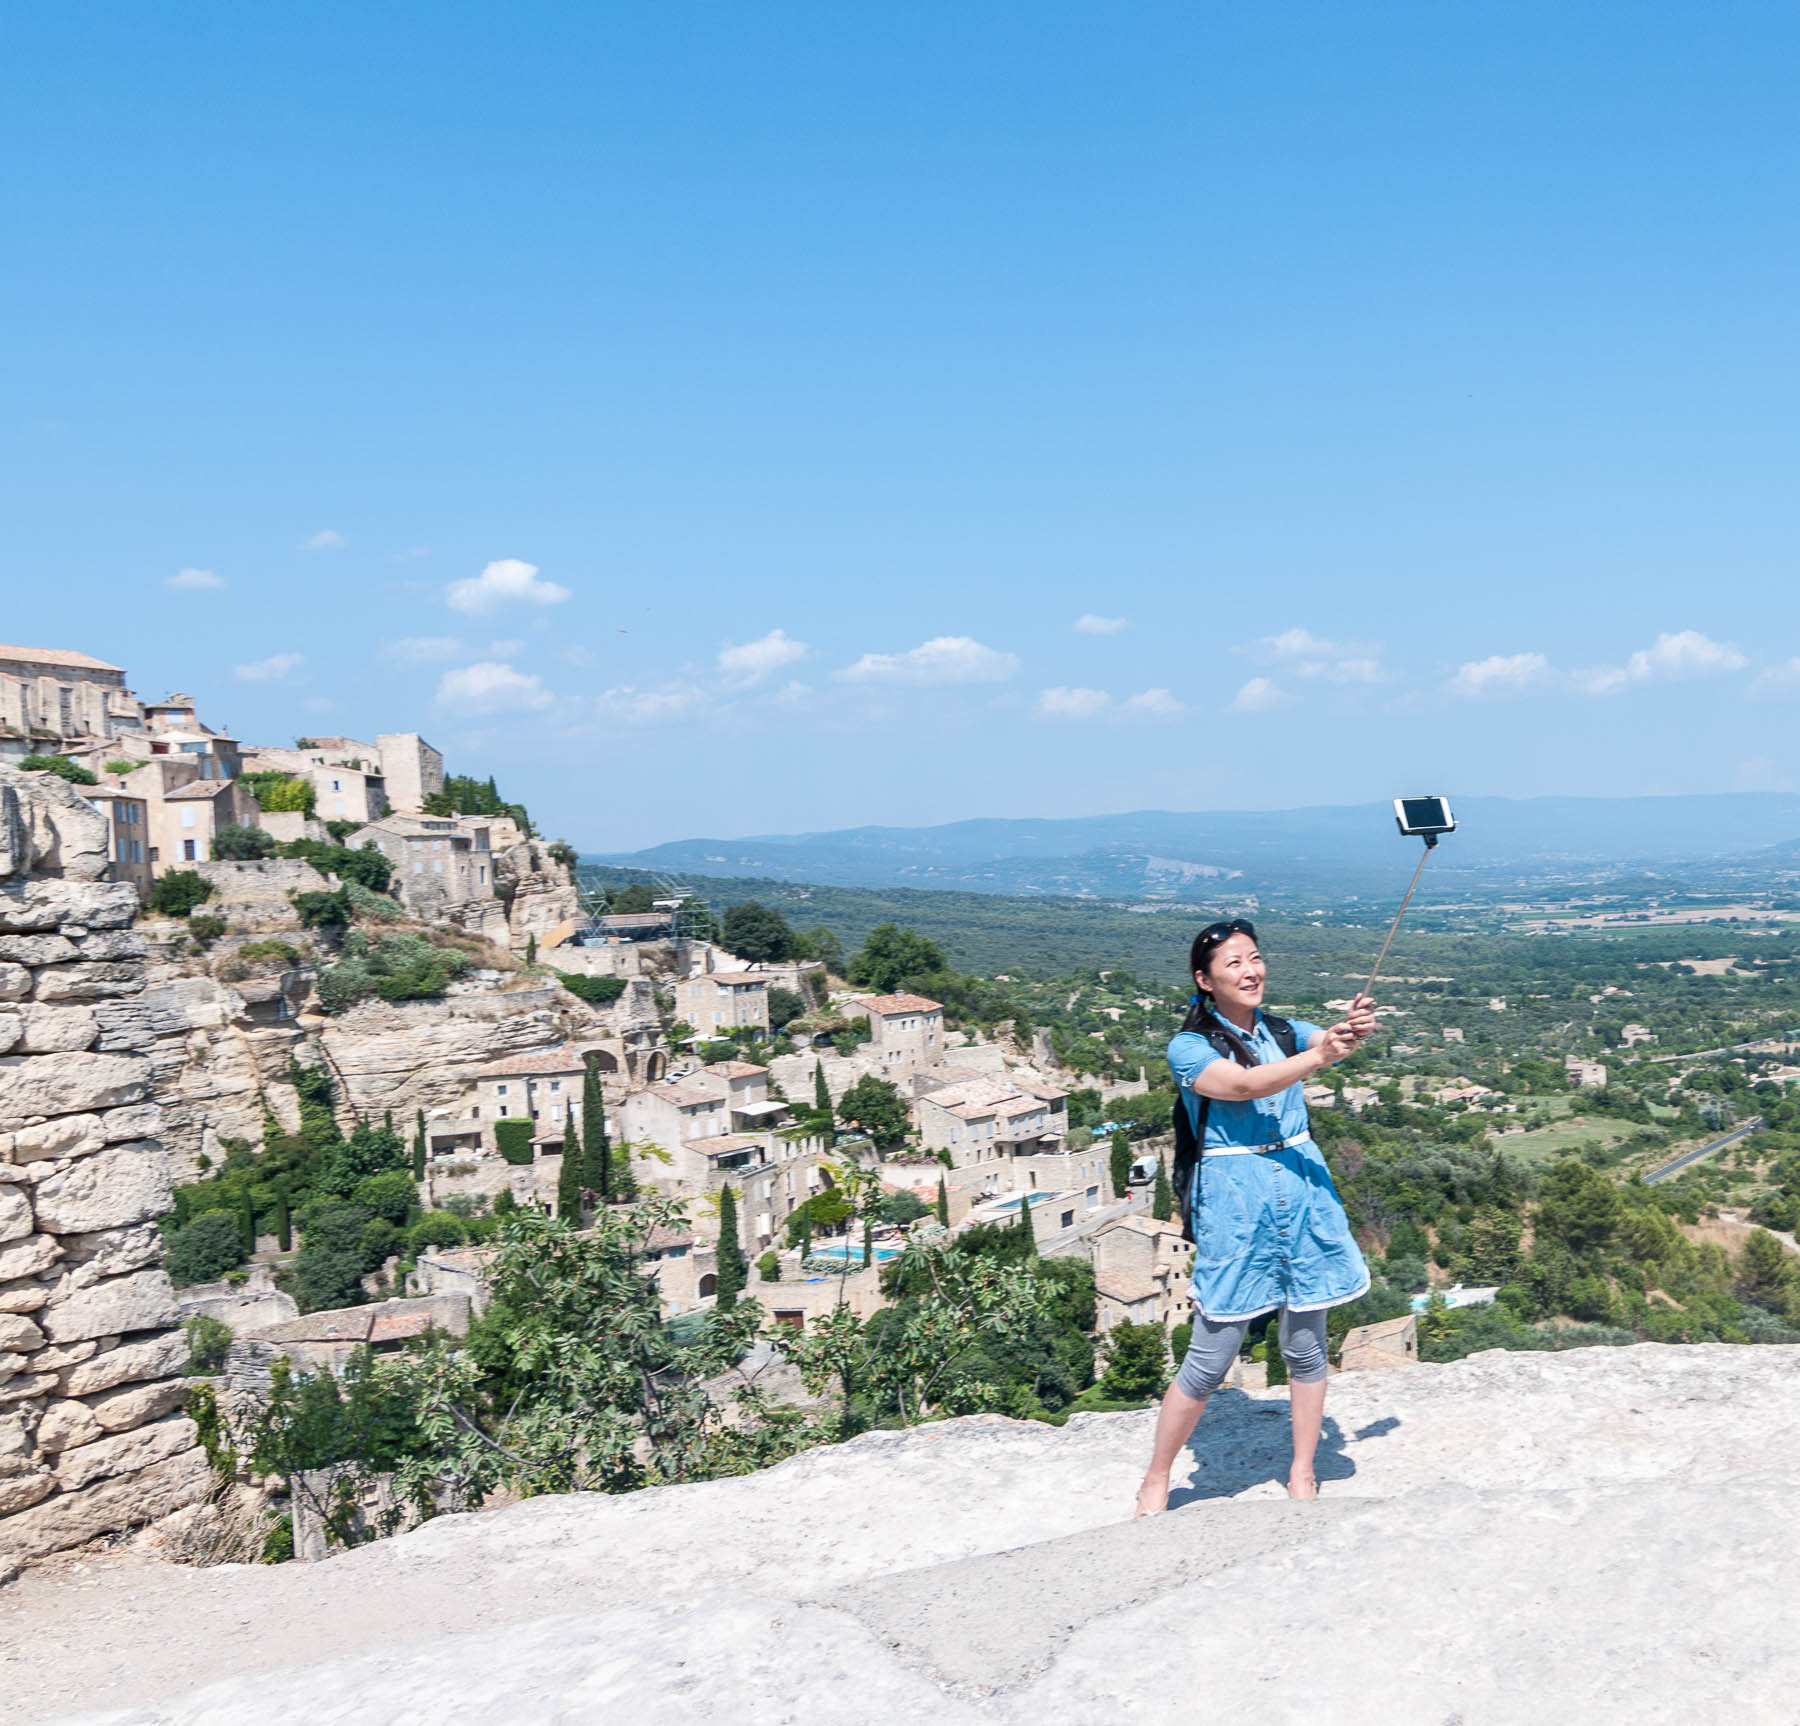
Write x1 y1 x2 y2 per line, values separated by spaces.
1138 918 1375 1515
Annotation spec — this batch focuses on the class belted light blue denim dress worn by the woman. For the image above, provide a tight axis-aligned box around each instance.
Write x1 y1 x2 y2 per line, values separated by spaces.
1168 1013 1368 1323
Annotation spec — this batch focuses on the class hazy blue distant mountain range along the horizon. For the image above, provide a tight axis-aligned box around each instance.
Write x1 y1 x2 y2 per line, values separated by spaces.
589 792 1800 903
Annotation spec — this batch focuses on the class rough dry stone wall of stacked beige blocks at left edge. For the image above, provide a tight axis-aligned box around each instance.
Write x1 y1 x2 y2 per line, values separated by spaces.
0 767 211 1569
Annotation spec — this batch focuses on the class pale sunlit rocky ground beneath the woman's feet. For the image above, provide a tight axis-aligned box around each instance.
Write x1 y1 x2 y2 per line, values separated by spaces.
10 1346 1800 1726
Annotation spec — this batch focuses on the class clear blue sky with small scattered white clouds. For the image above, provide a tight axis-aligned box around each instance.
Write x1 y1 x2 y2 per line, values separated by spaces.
0 0 1800 851
